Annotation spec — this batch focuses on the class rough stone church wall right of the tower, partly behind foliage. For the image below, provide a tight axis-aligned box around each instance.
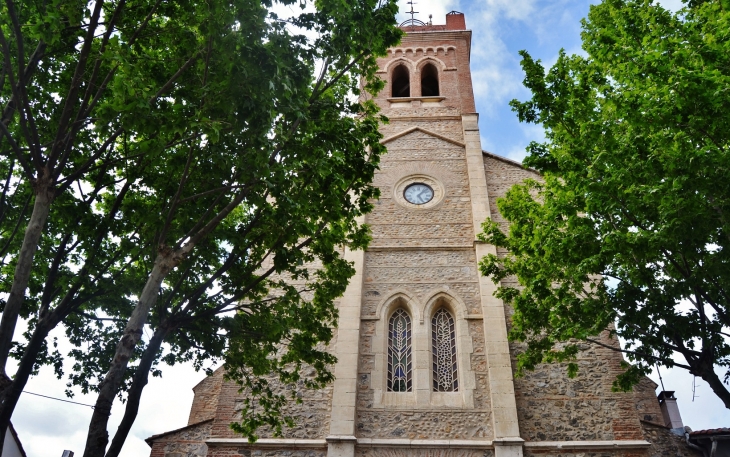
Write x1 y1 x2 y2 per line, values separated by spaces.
484 155 661 442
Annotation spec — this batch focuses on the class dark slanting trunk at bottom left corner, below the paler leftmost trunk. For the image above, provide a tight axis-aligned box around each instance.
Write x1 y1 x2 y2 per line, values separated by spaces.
0 319 59 457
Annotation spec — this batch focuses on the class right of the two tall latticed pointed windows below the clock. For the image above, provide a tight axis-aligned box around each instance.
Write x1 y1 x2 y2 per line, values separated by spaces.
431 308 459 392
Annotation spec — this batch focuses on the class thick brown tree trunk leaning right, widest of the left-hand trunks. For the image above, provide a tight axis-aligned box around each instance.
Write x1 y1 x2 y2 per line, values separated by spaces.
83 251 180 457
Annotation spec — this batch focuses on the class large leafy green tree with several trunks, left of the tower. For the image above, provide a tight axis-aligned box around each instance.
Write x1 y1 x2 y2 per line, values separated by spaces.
0 0 400 456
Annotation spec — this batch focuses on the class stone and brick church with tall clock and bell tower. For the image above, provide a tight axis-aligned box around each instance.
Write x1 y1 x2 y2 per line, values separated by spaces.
147 11 702 457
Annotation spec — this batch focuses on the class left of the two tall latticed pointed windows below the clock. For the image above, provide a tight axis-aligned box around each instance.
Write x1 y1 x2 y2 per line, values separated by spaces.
388 309 413 392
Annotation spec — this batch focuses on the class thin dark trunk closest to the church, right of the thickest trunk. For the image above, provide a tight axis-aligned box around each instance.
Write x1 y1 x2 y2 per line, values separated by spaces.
106 325 172 457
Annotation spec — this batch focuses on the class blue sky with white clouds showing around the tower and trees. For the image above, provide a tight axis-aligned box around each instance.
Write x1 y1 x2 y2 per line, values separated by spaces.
8 0 730 457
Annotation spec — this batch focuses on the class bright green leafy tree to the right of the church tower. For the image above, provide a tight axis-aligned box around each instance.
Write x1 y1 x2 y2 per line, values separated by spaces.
481 0 730 408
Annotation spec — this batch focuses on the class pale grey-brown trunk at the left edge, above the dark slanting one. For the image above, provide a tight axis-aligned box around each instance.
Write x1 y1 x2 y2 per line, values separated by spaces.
0 176 53 372
